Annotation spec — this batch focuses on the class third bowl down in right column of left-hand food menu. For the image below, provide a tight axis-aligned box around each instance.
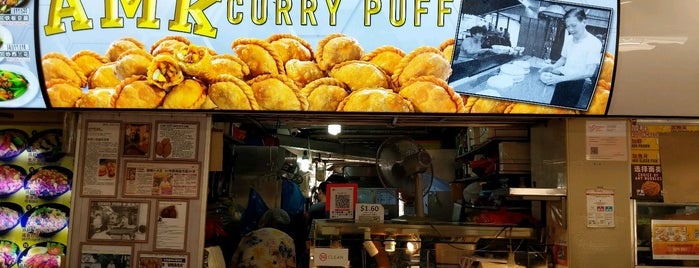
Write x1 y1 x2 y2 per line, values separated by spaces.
21 203 70 237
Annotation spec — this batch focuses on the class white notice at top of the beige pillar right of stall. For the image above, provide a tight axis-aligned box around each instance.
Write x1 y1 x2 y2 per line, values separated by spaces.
585 120 629 161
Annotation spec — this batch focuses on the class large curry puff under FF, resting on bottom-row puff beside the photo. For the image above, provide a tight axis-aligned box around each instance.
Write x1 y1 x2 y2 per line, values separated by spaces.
392 46 451 86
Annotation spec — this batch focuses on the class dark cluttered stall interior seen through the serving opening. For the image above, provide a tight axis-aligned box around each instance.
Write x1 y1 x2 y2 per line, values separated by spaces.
207 114 566 267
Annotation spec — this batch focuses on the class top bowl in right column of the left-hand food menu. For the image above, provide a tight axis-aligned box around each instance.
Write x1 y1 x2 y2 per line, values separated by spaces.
27 129 66 162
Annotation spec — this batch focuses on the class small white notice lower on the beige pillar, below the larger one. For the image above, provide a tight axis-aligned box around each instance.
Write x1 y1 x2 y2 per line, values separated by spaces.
585 188 614 228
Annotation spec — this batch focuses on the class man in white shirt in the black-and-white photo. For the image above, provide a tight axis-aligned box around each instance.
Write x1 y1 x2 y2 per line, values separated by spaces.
540 8 602 107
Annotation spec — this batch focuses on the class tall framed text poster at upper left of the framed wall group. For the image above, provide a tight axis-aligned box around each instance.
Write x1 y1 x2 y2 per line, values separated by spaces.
80 122 121 197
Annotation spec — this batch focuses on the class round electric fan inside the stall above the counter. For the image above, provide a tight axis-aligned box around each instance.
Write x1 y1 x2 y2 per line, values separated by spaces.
376 136 434 218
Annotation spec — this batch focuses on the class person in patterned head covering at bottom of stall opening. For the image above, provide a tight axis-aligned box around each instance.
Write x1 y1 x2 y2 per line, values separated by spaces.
229 208 296 268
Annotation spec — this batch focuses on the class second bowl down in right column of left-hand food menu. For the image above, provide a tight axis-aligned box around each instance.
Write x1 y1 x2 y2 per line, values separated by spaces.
24 166 73 200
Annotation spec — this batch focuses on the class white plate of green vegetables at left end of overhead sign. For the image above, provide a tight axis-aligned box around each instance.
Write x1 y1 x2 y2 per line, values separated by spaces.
0 64 39 107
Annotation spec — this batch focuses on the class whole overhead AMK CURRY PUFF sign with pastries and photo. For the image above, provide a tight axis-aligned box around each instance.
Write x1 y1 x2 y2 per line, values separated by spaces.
36 0 618 114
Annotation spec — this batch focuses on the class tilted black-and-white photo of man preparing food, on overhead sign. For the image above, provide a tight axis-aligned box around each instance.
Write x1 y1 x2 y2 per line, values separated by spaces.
449 0 616 111
